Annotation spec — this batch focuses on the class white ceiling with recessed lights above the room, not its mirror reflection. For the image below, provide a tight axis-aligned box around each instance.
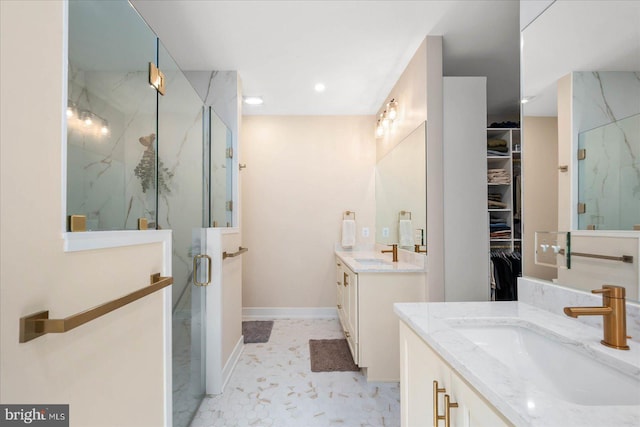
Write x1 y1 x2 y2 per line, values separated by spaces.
132 0 520 115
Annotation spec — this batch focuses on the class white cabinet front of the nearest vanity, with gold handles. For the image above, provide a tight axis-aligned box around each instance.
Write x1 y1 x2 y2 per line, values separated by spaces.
400 321 512 427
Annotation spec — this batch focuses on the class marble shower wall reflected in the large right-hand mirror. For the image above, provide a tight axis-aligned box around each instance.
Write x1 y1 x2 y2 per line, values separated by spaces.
573 71 640 230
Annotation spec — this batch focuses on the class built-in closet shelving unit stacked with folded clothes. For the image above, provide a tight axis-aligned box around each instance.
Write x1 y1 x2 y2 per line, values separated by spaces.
487 128 522 251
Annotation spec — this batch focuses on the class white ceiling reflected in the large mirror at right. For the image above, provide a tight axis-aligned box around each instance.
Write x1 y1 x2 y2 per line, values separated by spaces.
522 0 640 116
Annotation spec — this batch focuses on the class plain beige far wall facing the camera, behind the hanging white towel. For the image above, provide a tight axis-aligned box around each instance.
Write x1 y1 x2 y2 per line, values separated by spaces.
241 116 376 307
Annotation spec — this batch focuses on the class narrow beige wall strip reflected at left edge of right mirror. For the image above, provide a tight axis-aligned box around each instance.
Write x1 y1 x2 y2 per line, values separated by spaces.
522 117 559 280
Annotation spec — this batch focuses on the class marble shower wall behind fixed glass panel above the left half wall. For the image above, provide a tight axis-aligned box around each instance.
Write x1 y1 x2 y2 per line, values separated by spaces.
67 69 156 230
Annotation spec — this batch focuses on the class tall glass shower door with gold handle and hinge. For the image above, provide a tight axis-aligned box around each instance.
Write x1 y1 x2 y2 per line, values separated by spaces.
157 43 208 427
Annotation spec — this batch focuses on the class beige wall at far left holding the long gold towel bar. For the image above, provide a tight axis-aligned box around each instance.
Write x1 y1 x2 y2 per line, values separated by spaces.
0 1 164 427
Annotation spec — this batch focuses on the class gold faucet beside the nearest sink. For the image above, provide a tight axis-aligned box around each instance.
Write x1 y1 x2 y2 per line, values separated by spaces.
564 285 629 350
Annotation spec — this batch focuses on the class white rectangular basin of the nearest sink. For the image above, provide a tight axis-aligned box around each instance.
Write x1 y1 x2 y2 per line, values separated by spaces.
451 322 640 406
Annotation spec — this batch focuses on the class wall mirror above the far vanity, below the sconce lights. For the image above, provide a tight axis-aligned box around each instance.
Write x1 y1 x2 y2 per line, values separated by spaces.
375 122 427 250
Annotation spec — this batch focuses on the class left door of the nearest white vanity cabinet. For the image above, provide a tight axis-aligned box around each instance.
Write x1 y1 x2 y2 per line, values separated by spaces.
400 322 451 427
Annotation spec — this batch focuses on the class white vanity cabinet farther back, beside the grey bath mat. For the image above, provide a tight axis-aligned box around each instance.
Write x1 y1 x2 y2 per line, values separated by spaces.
336 257 426 381
